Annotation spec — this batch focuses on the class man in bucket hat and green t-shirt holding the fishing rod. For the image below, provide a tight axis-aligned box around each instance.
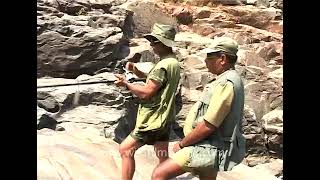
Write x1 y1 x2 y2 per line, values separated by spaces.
115 23 180 180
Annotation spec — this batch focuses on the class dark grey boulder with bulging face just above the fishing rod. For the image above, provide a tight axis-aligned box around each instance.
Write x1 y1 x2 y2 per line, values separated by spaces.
37 28 123 78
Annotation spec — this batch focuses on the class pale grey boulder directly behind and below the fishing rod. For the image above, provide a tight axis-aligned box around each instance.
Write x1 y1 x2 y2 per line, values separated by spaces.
38 72 138 142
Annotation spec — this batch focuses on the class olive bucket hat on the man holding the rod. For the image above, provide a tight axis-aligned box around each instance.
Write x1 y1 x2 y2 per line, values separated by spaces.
144 23 177 47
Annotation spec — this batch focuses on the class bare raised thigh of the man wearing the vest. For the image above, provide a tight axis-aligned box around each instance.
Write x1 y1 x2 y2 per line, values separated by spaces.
152 158 185 180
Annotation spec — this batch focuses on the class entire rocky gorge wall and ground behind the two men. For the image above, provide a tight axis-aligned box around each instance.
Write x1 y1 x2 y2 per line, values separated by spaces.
37 0 283 179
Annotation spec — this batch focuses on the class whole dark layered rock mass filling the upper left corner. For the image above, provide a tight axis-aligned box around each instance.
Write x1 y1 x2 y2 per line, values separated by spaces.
37 0 131 78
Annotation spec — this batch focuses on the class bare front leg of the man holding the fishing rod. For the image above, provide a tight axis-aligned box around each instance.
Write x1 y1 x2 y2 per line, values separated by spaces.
119 135 142 180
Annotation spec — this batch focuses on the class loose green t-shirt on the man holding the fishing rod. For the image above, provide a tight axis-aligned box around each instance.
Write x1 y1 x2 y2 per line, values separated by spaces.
134 54 180 132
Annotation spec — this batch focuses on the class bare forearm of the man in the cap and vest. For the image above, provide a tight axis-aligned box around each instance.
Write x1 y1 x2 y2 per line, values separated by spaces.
180 120 216 147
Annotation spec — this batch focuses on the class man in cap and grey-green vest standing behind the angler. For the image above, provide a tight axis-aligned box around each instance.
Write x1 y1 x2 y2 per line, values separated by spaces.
152 37 245 180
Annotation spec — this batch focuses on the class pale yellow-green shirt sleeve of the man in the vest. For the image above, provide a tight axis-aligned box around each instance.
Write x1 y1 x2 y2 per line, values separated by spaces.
203 81 234 127
